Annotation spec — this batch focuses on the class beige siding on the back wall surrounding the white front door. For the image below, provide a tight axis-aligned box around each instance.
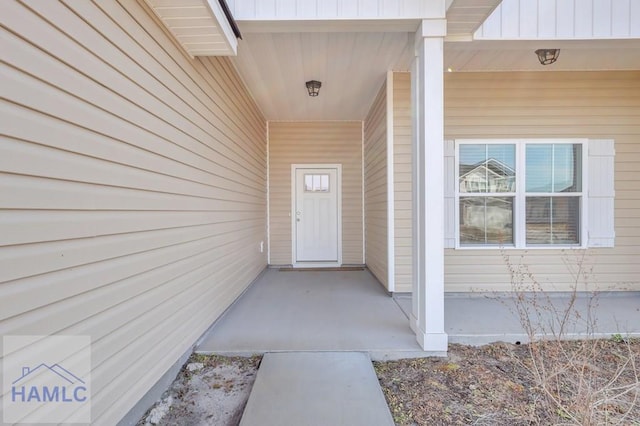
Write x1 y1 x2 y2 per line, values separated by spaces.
269 121 363 265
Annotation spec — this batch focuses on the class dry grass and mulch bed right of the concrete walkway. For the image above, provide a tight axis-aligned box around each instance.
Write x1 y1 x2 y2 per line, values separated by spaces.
374 339 640 426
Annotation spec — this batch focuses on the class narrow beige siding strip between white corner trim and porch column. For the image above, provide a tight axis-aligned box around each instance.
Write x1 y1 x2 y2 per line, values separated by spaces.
393 72 413 292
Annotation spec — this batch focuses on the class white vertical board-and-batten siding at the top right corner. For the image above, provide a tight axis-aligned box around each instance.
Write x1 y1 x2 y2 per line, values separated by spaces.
474 0 640 40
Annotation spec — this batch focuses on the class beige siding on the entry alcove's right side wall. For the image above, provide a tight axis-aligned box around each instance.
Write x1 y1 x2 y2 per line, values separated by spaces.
364 81 389 289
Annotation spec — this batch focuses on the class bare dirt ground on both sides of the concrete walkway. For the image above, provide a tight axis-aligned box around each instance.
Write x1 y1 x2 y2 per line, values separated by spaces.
139 336 640 426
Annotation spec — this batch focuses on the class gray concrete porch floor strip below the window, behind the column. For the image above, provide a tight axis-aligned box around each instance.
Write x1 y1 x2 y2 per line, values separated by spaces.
394 292 640 345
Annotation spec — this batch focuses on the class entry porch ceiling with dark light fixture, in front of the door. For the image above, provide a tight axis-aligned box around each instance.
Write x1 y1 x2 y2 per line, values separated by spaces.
233 32 411 120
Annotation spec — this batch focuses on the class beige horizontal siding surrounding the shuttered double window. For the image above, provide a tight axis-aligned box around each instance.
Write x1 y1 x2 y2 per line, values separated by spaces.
445 71 640 291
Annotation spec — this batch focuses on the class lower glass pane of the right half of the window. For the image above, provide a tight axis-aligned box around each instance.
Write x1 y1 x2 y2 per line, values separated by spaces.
526 197 580 244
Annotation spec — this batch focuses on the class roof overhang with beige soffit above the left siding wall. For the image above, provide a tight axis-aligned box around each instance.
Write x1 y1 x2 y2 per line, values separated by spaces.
145 0 240 57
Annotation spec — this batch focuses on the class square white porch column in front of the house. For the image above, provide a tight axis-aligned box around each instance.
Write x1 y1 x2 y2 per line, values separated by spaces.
411 19 448 351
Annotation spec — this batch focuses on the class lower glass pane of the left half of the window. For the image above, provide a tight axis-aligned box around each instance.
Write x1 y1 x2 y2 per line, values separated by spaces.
460 197 513 245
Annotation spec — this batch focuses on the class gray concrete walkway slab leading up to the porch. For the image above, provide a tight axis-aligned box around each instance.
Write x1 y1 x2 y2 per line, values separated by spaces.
240 352 394 426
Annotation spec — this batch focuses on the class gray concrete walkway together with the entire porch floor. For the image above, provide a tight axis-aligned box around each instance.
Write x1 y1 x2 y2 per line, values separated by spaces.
196 269 640 426
